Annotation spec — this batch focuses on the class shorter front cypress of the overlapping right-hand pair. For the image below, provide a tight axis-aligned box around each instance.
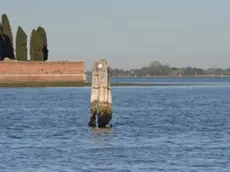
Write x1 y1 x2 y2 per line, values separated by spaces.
30 29 44 61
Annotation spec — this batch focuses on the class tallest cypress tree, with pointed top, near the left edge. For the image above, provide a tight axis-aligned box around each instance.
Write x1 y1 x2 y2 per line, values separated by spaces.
2 14 14 59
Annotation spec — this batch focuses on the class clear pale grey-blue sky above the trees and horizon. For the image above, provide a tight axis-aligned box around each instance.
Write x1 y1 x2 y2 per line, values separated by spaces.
0 0 230 69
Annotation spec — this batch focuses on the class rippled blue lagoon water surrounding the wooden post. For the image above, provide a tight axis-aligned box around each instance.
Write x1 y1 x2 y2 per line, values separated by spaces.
0 78 230 172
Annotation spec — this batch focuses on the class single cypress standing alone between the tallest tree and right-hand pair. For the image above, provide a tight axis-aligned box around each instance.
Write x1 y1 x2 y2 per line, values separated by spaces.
16 26 27 61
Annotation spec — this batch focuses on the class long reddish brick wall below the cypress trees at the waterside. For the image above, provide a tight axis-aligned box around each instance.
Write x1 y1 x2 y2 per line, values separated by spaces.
0 61 86 82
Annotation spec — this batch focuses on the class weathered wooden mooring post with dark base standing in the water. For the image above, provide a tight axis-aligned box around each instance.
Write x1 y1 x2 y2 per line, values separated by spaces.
89 60 112 128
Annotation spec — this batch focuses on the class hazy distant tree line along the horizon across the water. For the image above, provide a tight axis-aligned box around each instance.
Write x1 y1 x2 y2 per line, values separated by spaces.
86 61 230 77
